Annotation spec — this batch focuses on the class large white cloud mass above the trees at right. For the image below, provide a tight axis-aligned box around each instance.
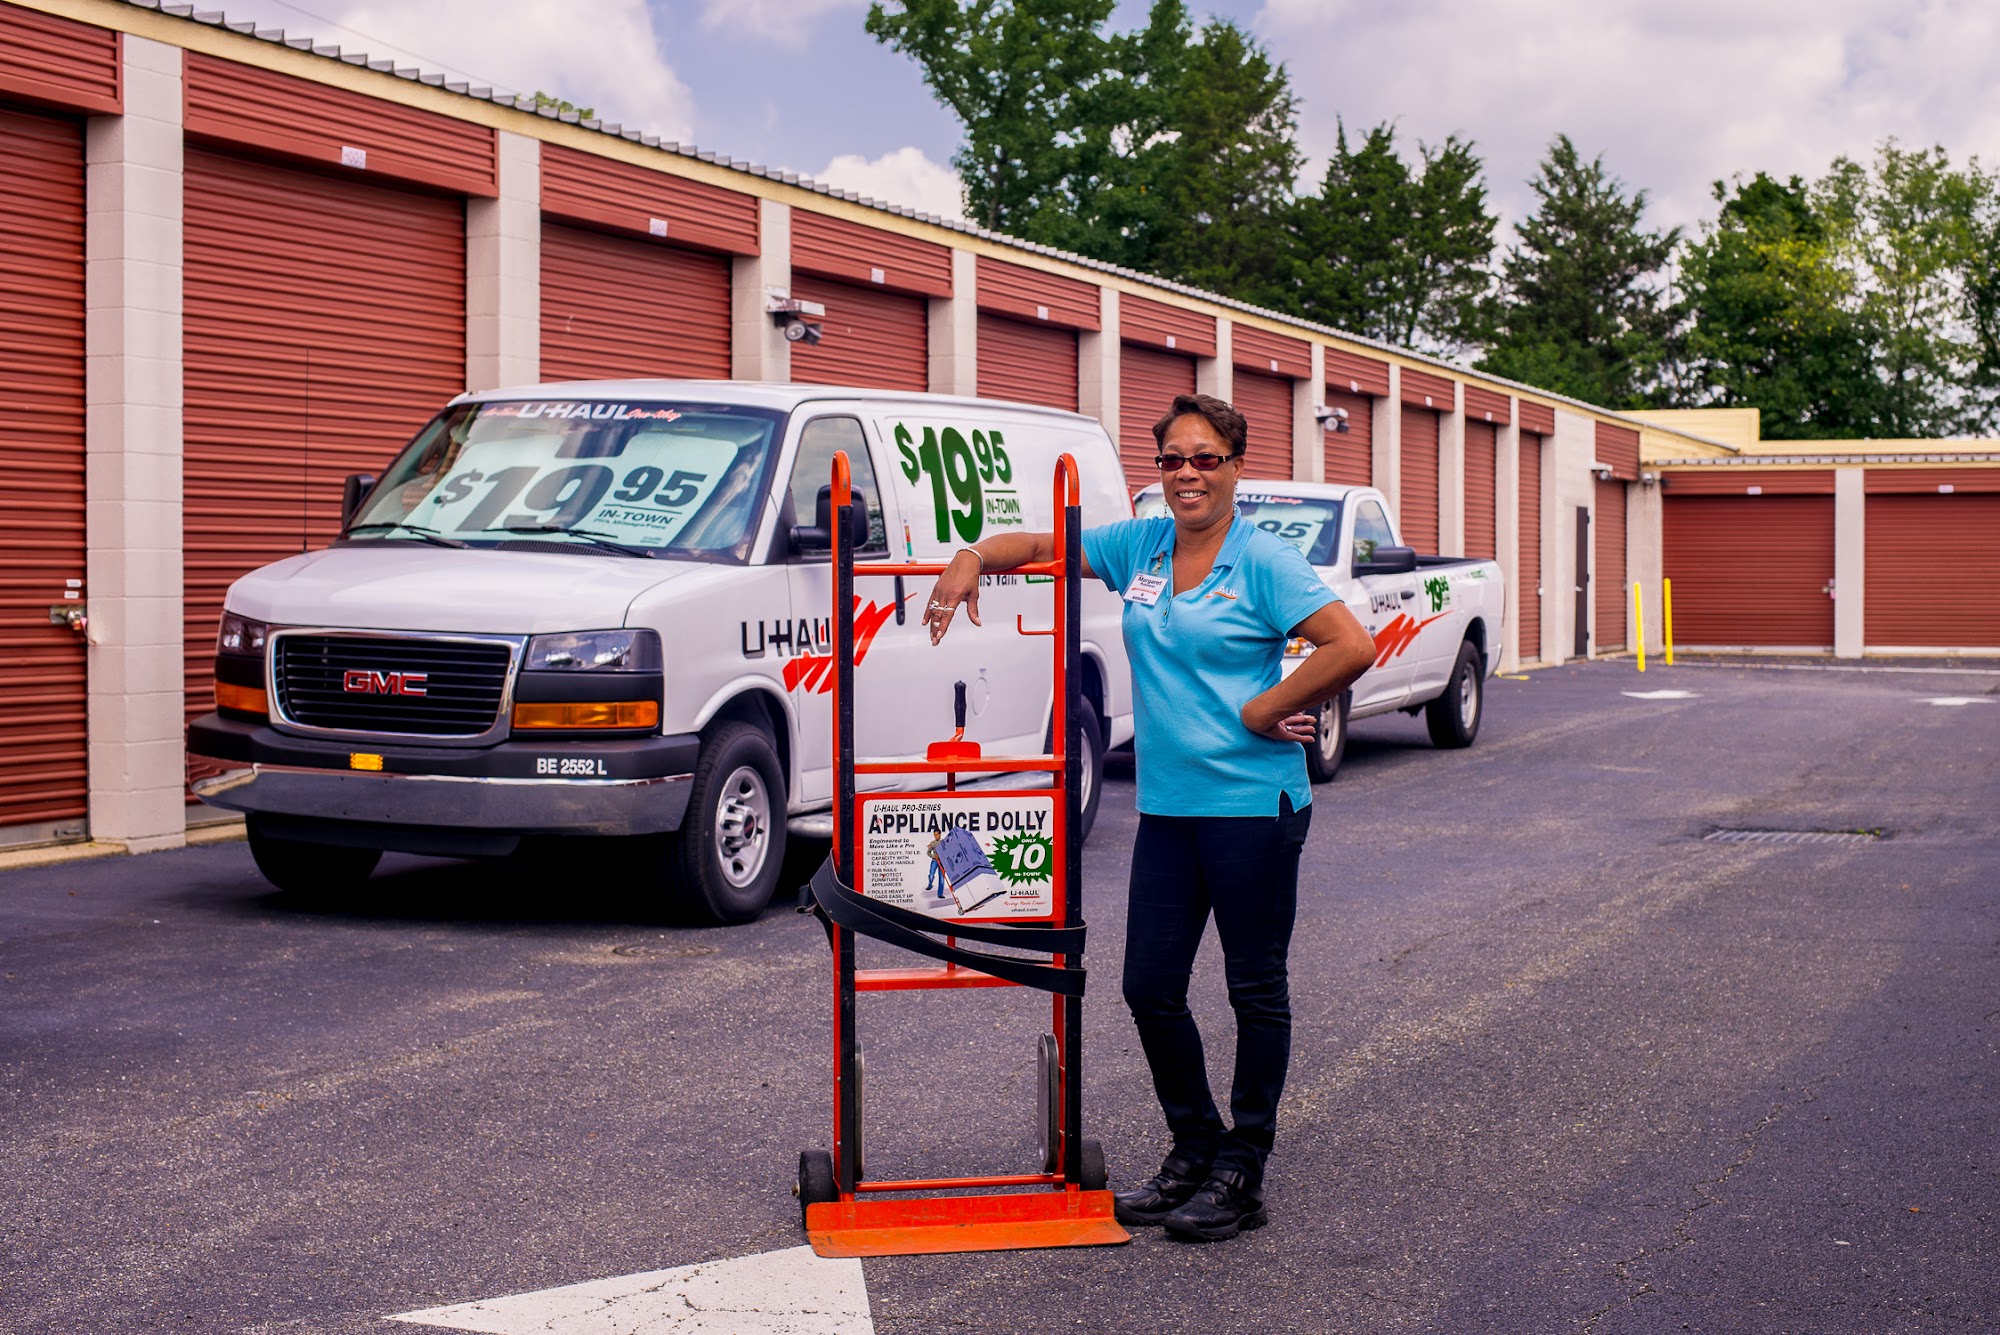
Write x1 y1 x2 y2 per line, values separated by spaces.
1252 0 2000 236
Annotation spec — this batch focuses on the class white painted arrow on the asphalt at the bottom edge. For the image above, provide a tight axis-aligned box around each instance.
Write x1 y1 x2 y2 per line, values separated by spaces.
390 1247 874 1335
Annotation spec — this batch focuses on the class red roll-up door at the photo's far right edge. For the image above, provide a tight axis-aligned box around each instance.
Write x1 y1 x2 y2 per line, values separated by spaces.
1862 495 2000 650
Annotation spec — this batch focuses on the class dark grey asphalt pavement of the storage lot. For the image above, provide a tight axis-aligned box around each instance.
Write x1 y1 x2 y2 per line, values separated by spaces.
0 662 2000 1335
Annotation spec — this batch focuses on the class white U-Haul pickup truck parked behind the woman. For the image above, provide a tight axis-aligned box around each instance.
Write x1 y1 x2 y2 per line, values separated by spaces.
1132 480 1506 783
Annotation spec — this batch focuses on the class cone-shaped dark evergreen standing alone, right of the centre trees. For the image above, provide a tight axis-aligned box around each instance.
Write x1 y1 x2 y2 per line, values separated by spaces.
1478 134 1680 408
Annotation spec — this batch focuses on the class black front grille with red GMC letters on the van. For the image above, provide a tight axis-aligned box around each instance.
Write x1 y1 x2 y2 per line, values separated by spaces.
272 634 514 737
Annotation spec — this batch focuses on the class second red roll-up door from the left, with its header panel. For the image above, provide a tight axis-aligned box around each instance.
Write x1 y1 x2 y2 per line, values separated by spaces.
182 52 494 731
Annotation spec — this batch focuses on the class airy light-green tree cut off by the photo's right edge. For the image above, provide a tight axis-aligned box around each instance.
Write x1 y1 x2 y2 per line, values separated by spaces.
1812 140 2000 436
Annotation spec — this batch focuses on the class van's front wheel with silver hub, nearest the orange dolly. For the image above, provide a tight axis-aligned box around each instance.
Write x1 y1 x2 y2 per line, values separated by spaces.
670 723 786 923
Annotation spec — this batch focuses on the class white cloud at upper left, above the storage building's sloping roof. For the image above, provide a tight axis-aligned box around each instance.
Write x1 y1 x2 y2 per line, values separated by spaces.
258 0 694 142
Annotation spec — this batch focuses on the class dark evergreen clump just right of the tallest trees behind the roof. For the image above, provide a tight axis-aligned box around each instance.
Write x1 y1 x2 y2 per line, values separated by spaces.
1286 122 1498 356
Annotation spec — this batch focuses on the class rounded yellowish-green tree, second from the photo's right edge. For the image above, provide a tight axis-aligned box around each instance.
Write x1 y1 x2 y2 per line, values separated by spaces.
1680 172 1884 440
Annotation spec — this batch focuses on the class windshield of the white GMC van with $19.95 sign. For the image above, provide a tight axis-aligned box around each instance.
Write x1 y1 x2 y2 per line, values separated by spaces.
344 400 784 564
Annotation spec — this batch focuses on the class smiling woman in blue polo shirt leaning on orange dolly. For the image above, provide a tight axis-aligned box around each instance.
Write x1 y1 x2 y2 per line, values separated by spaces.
924 394 1374 1239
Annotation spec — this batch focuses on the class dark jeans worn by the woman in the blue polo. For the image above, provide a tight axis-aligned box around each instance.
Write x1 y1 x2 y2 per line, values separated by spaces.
1124 799 1312 1183
